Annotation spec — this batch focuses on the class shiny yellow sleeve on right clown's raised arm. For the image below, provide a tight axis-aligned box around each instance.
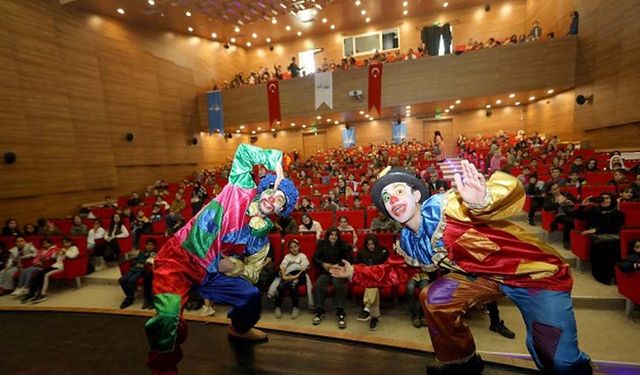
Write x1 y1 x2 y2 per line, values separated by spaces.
445 172 525 222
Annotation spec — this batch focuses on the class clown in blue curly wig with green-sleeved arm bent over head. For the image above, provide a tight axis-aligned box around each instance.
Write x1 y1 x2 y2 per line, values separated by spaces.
145 144 298 374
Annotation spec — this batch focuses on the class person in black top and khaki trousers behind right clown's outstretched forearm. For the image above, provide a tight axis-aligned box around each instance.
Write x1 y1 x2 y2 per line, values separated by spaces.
353 234 389 331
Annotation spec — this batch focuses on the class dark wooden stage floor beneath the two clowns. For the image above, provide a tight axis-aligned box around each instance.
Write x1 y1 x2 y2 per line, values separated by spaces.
0 311 534 375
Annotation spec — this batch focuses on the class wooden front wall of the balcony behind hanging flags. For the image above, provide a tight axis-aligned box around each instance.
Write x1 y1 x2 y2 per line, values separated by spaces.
208 37 577 131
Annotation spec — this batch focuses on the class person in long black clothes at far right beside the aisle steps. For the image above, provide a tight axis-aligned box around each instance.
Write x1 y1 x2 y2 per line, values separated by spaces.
575 193 624 285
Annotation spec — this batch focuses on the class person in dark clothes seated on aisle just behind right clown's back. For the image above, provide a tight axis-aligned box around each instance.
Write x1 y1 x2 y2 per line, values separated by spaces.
542 182 577 250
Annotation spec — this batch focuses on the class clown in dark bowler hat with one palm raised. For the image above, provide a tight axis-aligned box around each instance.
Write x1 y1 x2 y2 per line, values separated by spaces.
332 161 592 375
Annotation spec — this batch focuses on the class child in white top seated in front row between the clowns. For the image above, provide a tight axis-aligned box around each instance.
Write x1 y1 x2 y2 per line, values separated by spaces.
275 238 309 319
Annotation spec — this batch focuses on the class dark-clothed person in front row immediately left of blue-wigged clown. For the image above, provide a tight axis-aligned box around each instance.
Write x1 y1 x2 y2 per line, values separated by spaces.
118 238 158 310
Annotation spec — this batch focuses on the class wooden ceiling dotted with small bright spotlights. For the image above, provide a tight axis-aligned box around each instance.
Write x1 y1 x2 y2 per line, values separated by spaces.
59 0 487 47
